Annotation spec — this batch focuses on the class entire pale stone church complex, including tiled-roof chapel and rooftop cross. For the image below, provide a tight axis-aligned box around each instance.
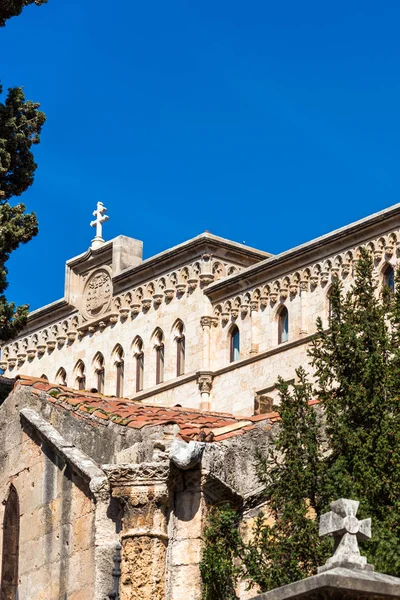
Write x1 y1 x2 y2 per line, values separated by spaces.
0 203 400 600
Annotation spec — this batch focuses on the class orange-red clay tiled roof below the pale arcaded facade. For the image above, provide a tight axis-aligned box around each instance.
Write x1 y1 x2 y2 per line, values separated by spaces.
14 375 279 442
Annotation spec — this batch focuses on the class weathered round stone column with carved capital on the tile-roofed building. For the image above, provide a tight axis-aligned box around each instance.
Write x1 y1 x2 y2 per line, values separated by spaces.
109 463 170 600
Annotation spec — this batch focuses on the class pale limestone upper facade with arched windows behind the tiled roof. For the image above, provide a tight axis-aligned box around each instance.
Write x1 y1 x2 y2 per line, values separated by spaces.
1 205 400 415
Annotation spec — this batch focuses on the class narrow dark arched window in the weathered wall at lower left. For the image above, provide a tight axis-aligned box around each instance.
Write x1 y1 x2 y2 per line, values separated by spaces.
0 485 19 600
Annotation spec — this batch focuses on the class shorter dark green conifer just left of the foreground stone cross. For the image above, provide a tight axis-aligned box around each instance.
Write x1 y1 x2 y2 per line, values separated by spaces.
242 369 330 591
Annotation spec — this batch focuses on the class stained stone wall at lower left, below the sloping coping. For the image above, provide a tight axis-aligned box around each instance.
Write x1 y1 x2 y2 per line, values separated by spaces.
0 401 94 600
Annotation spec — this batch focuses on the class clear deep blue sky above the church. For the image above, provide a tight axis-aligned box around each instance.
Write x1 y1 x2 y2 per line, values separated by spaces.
0 0 400 309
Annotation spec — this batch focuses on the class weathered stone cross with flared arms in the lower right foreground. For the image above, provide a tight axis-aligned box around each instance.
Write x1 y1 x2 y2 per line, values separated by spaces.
318 498 374 573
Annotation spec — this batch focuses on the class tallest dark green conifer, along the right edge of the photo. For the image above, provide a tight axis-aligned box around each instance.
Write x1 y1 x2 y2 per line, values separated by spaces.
310 250 400 576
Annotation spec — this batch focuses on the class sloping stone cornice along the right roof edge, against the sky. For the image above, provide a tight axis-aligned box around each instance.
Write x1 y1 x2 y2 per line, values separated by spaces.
205 203 400 302
